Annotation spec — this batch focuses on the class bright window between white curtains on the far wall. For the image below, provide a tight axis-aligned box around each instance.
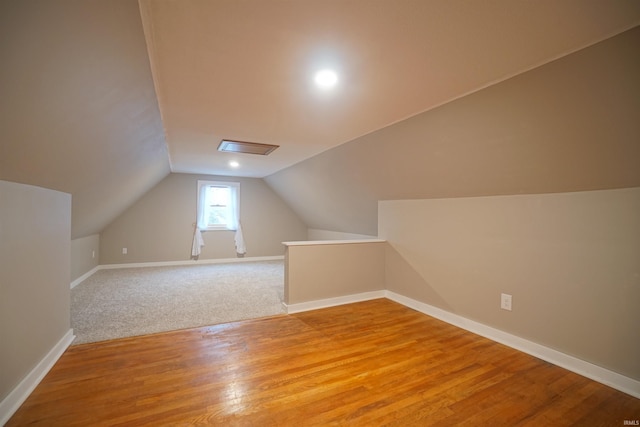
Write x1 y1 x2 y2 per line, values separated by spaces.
198 181 240 231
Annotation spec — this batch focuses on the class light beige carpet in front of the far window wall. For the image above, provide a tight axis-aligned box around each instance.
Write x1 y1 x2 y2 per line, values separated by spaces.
71 261 284 344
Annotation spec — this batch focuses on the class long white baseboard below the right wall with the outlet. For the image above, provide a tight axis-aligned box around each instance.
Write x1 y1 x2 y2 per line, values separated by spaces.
386 291 640 399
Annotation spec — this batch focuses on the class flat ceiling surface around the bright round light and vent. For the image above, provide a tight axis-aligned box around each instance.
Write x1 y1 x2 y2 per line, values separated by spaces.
140 0 640 177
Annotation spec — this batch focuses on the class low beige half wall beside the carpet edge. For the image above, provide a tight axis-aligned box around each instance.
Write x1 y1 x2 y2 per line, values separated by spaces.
284 242 385 304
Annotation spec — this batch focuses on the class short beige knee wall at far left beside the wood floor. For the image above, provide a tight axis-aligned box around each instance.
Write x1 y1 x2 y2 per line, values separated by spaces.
0 181 71 402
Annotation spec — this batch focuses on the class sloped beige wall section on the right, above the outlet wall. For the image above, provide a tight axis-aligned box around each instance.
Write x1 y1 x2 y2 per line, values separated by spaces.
266 27 640 235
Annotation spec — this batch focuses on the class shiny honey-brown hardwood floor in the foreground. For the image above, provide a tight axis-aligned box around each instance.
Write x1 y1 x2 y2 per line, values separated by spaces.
7 299 640 426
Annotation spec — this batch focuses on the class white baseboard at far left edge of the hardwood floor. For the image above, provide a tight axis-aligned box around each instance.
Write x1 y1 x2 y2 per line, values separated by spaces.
0 329 75 426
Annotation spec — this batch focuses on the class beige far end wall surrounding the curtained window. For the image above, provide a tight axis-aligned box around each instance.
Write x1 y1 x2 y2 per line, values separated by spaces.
100 174 307 264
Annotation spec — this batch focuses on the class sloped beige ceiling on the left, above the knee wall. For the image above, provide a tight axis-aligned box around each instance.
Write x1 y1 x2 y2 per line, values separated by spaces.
0 0 170 238
